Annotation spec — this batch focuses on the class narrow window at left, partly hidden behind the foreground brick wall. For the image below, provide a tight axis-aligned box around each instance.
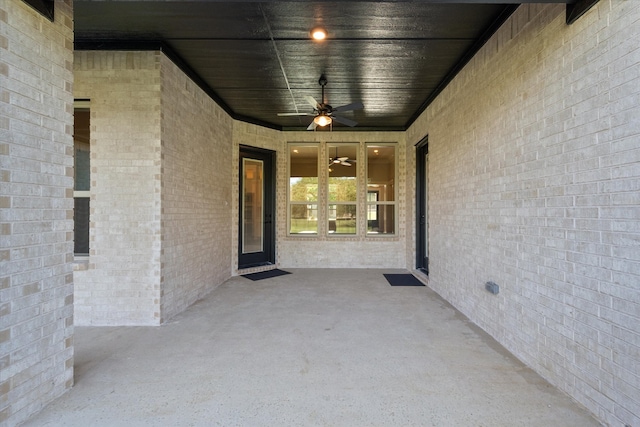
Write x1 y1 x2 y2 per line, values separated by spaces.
73 102 91 255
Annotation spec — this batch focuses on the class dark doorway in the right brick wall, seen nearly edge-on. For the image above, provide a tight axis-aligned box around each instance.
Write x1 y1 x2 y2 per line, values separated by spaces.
416 137 429 274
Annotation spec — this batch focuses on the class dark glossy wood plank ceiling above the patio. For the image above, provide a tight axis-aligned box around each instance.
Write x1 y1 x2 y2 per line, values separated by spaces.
74 0 571 130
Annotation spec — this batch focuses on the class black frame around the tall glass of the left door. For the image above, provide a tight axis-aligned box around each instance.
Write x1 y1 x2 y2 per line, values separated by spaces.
236 145 276 269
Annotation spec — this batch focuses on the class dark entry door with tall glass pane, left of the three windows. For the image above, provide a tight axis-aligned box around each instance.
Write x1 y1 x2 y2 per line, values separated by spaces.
238 146 275 268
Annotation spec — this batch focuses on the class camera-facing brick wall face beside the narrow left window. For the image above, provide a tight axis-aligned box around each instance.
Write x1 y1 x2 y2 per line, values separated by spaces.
74 51 161 325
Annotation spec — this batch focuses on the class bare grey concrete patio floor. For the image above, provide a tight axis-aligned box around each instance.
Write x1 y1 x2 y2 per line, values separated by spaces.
25 269 599 427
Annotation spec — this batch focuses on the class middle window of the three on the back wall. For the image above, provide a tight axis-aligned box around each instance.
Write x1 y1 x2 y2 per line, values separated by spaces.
327 144 358 234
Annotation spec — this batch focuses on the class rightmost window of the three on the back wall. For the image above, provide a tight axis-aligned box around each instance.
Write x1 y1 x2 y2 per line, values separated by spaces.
367 144 397 234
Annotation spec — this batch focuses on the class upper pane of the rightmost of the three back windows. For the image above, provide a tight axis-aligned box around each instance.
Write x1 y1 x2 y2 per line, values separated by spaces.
367 145 396 202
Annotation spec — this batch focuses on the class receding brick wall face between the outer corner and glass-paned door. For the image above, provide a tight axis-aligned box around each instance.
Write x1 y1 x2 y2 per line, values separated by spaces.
161 56 234 321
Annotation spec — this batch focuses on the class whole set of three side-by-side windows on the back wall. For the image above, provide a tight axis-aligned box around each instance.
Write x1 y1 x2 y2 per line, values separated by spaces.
289 143 397 237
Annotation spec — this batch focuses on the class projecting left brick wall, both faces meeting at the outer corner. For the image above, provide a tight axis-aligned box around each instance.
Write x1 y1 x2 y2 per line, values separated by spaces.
74 51 233 325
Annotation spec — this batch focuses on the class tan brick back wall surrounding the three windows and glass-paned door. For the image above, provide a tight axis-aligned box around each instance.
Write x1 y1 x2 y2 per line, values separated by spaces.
233 127 407 272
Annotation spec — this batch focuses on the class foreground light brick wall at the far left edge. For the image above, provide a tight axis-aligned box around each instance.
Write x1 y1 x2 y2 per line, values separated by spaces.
0 0 73 425
